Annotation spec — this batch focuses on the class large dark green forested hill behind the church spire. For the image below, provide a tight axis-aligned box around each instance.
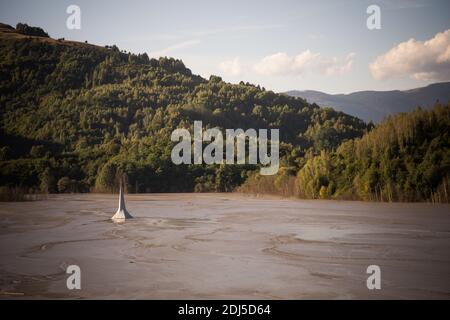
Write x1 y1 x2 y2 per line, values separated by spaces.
0 24 368 192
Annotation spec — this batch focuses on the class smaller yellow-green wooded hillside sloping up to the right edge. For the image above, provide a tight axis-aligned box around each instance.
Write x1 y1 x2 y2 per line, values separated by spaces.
241 104 450 203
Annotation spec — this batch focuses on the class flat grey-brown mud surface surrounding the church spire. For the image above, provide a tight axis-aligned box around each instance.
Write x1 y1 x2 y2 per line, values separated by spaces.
0 194 450 299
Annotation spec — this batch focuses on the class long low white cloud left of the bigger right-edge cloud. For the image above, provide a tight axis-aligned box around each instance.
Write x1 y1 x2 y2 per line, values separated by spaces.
253 50 355 76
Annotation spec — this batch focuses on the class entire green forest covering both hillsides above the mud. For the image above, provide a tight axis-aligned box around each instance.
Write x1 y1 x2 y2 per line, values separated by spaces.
0 24 450 202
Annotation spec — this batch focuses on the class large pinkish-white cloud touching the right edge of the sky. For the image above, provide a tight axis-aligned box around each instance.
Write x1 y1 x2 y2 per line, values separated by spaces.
369 29 450 81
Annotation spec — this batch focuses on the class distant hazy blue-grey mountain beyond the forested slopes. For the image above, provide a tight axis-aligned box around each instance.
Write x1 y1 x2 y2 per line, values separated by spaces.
285 82 450 122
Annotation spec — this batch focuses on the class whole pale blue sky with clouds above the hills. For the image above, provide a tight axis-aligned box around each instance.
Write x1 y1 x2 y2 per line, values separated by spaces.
0 0 450 93
